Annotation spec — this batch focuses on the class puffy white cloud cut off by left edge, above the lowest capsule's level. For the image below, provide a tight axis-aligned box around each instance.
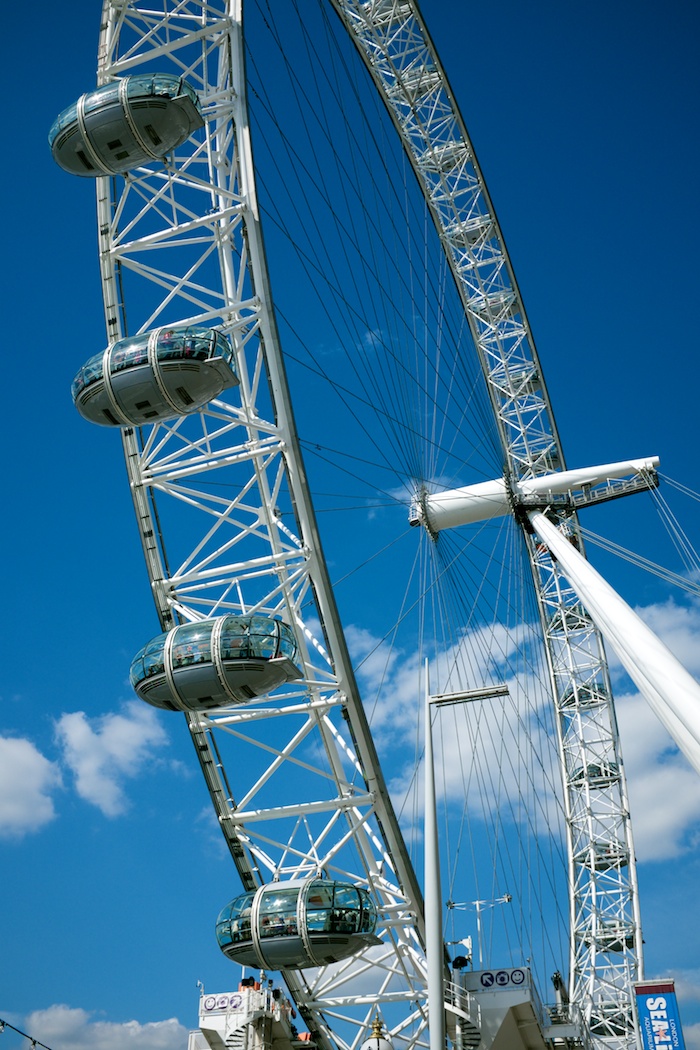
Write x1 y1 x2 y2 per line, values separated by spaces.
0 737 61 839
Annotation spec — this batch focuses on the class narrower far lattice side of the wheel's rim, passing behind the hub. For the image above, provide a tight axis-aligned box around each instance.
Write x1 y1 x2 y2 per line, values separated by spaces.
333 0 641 1047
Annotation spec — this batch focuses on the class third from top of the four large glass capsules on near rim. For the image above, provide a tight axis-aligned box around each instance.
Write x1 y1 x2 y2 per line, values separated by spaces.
131 614 301 711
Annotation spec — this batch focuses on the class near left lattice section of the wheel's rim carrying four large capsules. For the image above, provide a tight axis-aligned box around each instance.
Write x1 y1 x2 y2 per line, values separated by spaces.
98 6 440 1047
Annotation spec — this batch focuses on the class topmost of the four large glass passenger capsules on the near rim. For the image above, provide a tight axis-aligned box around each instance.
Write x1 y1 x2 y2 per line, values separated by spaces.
48 74 204 176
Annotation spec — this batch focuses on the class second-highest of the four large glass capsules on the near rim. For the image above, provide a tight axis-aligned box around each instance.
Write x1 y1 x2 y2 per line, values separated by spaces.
70 326 238 426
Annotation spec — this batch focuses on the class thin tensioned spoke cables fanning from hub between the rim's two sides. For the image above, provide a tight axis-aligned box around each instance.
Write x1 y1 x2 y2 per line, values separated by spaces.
243 5 568 979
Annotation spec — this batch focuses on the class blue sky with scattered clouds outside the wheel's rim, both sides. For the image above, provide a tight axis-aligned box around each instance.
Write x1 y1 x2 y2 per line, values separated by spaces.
0 0 700 1050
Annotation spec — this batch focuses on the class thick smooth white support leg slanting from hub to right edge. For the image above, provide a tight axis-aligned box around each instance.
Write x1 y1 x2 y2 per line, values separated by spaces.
528 511 700 773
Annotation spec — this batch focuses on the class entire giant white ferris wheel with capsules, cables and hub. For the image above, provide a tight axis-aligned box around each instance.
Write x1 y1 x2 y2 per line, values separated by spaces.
51 0 700 1050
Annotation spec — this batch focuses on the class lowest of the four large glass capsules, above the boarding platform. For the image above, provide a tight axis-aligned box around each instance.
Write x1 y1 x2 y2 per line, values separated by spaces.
216 877 380 970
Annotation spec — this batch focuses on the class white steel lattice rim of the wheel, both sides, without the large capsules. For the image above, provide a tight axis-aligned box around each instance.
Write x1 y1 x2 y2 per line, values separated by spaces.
72 0 663 1048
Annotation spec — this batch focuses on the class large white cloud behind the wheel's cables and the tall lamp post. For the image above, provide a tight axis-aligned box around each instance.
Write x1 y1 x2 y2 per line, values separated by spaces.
346 627 561 837
